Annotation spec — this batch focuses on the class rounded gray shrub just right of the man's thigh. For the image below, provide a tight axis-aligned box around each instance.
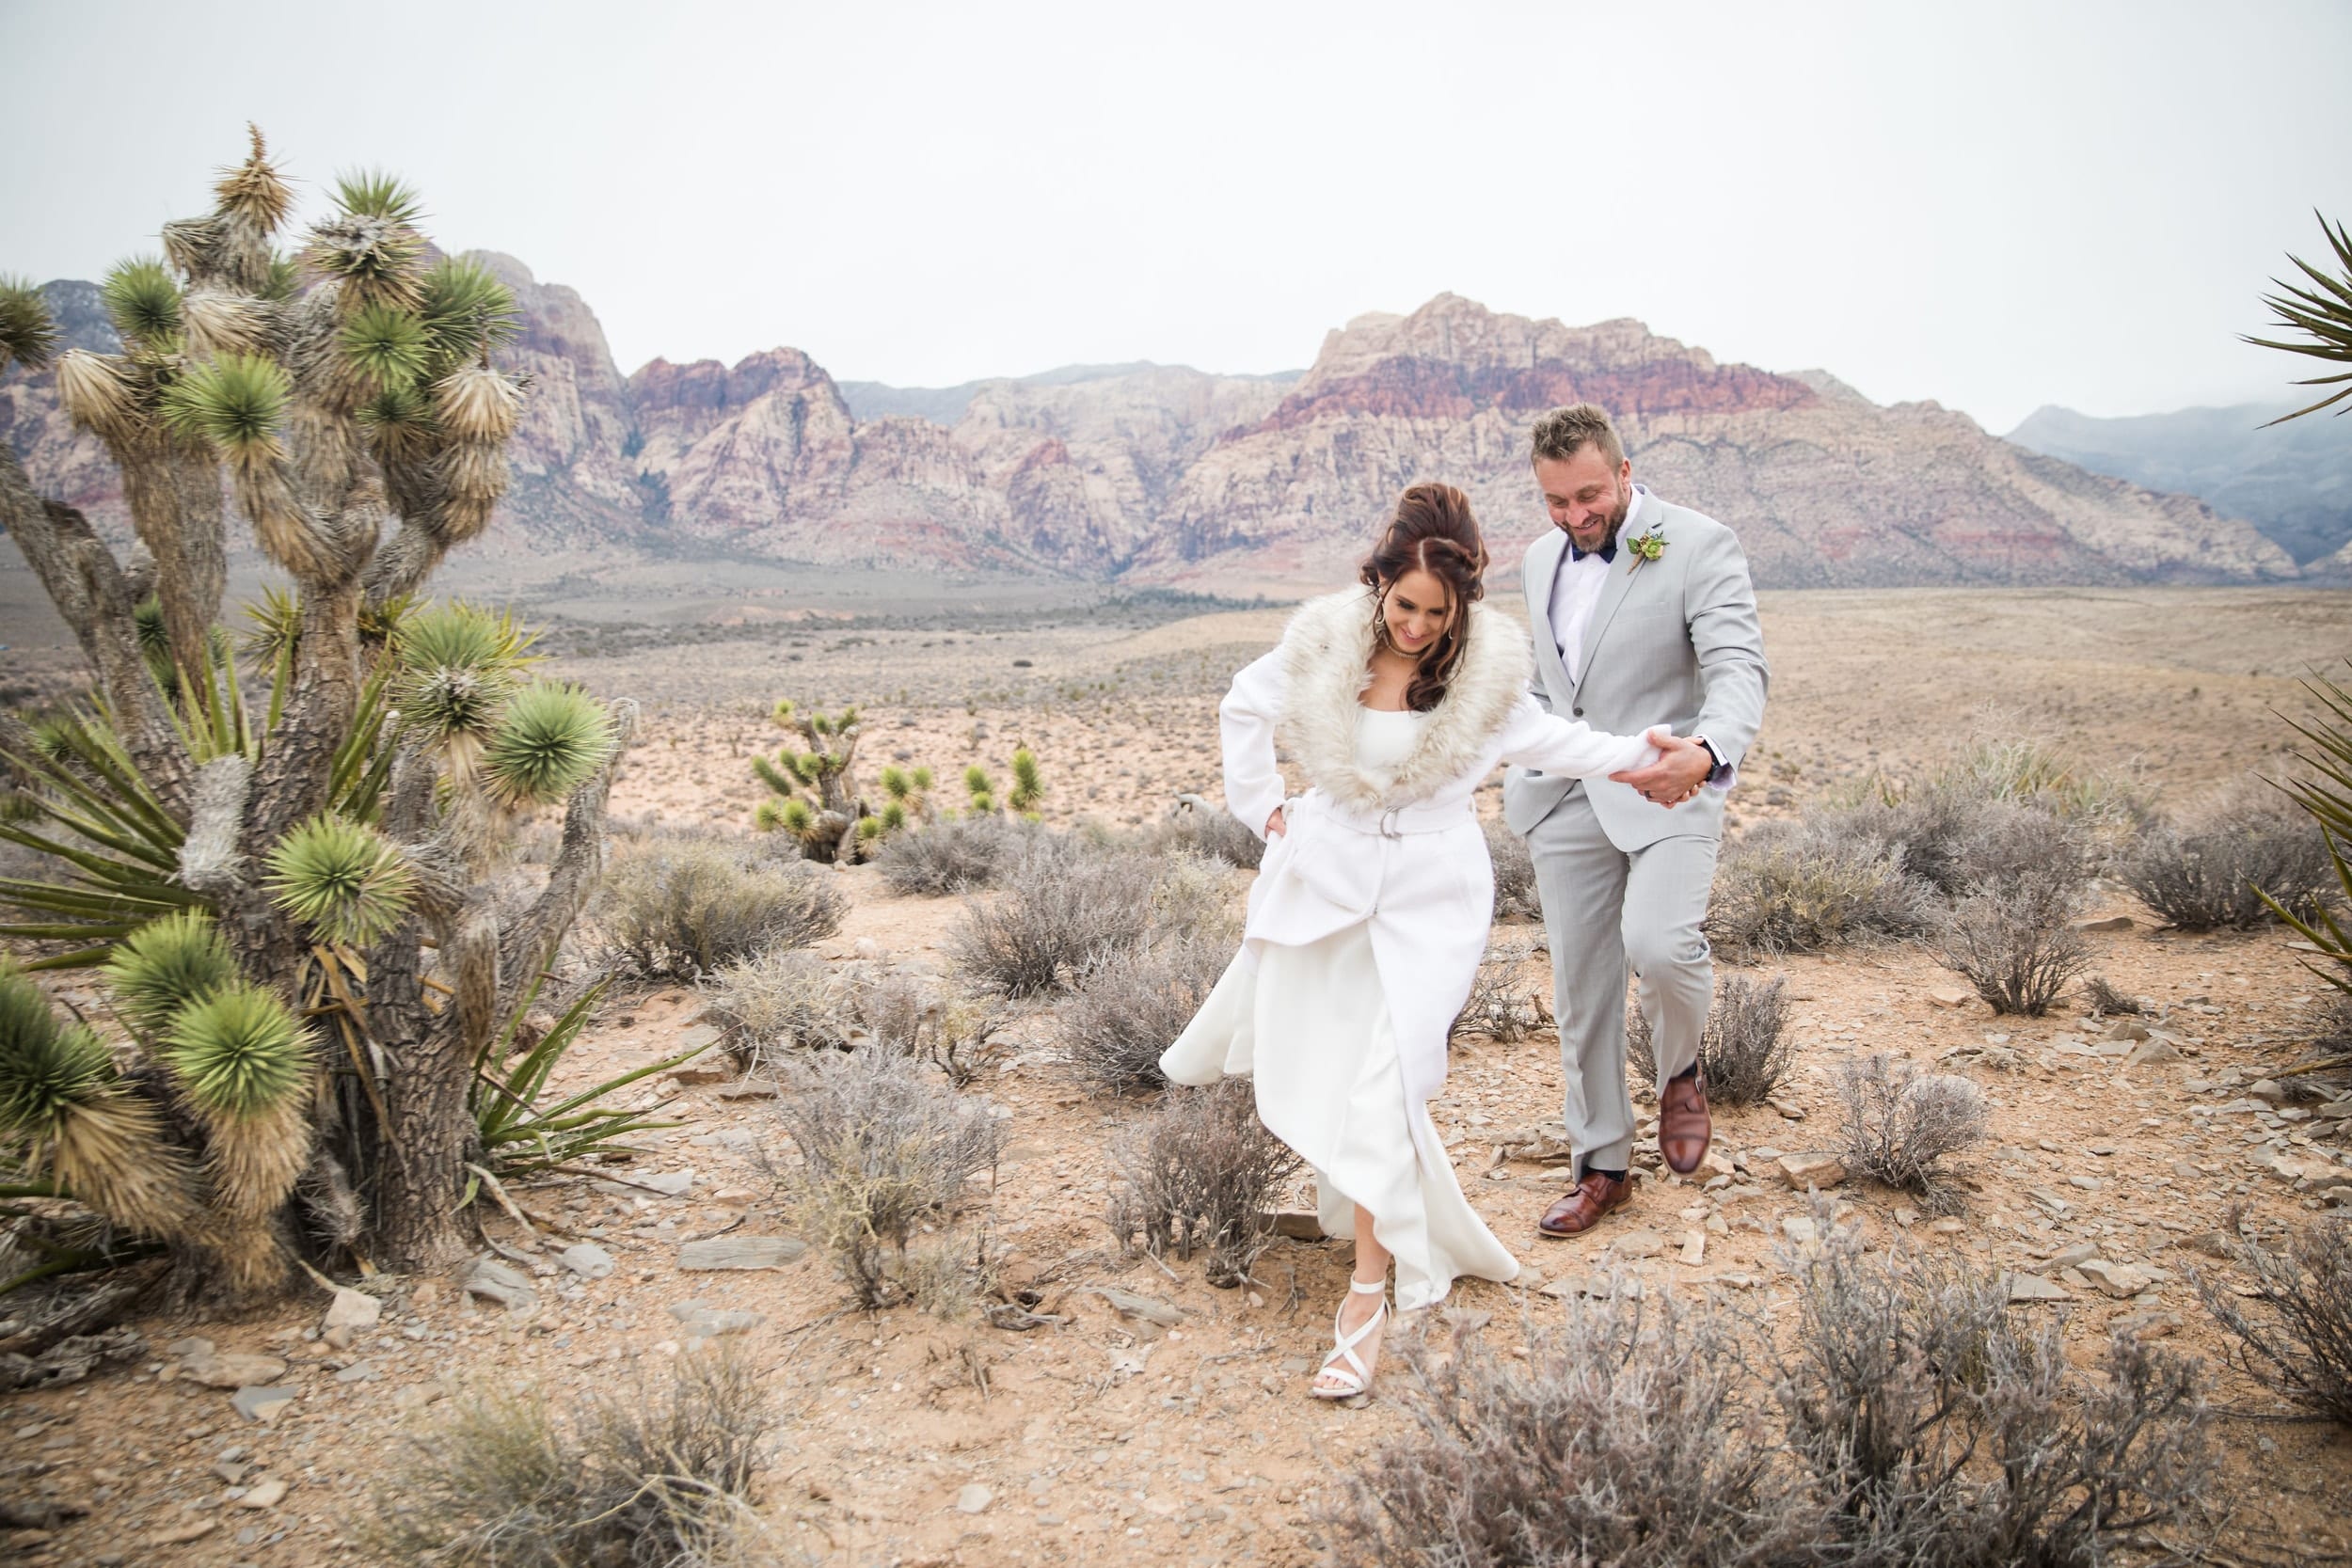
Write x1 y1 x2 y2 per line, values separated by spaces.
1708 818 1933 955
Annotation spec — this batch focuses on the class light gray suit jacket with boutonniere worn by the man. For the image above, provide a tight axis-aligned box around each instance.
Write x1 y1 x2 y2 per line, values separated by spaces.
1503 494 1769 851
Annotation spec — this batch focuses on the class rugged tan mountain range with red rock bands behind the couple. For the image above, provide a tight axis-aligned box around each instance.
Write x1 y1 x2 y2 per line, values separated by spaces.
0 262 2300 593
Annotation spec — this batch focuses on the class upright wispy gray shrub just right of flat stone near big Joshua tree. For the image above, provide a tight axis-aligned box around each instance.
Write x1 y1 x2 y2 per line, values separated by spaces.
765 1046 1000 1307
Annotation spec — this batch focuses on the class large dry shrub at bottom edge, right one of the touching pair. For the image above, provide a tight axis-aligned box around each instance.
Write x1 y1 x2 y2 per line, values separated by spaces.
1773 1206 2211 1568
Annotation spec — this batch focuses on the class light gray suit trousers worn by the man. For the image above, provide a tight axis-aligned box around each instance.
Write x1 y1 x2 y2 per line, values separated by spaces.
1527 790 1720 1180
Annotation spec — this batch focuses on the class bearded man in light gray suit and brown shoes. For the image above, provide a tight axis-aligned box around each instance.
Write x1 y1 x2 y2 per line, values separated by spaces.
1503 402 1767 1237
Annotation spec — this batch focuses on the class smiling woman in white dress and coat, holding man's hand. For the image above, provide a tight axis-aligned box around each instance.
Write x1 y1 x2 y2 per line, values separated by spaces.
1160 484 1665 1399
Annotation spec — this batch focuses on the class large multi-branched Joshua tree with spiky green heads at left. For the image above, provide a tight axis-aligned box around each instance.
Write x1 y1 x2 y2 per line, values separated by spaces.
0 132 633 1300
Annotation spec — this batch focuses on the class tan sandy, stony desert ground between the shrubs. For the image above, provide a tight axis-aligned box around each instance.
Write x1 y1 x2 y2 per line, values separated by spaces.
0 590 2352 1566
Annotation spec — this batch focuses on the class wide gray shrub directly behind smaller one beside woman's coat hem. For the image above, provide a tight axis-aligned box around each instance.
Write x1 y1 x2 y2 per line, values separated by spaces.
948 837 1235 997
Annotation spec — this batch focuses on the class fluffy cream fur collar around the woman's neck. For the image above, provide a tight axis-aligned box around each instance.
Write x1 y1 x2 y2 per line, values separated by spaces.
1279 588 1534 811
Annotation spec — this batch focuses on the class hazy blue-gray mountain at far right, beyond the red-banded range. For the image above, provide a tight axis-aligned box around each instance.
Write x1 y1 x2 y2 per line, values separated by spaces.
2007 400 2352 576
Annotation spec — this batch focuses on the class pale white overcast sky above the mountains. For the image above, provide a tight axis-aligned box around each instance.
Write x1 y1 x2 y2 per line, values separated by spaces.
0 0 2352 430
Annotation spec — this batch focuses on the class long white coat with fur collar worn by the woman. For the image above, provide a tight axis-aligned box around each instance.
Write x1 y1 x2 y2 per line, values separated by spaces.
1162 588 1659 1102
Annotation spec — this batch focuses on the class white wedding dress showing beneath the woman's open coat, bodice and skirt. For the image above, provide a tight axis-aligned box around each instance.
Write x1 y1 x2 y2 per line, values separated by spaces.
1162 707 1519 1312
